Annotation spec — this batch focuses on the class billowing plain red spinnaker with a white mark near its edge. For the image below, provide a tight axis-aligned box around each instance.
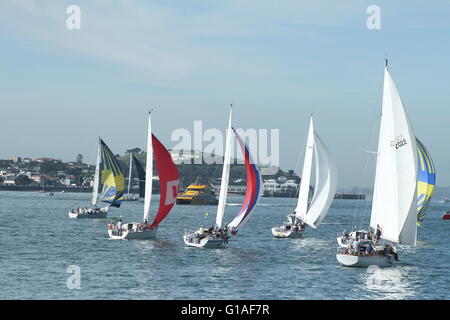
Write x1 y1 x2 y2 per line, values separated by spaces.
151 134 180 228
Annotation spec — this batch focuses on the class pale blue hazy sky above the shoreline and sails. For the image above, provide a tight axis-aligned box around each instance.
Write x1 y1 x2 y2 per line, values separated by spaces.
0 0 450 188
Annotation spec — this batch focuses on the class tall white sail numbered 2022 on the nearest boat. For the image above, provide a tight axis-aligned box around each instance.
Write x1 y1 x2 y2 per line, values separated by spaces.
370 68 417 245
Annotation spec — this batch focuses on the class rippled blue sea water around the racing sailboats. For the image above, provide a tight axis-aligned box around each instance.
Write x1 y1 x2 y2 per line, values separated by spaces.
0 192 450 299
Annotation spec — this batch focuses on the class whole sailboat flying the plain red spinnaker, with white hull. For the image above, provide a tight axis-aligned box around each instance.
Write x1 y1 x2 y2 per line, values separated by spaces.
108 113 180 240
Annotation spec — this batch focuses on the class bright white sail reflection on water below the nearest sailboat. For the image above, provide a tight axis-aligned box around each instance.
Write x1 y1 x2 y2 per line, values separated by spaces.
359 266 418 300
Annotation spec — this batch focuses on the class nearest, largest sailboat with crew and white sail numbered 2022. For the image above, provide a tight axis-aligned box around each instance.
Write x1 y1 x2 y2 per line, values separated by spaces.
336 60 418 267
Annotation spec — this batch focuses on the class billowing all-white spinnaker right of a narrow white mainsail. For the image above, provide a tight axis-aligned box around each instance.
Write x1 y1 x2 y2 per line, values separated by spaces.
304 133 337 228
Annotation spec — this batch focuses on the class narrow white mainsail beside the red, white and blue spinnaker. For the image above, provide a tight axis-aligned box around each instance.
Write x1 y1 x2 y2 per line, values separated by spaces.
216 107 233 227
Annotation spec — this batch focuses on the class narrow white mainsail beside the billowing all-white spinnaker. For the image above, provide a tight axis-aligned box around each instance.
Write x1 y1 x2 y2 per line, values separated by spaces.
295 117 314 220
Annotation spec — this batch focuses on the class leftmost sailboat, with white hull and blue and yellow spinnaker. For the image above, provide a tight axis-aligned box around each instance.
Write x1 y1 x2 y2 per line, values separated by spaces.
69 138 125 218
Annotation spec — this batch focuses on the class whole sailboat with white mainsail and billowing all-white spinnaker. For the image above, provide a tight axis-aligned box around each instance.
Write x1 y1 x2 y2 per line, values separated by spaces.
272 116 337 238
